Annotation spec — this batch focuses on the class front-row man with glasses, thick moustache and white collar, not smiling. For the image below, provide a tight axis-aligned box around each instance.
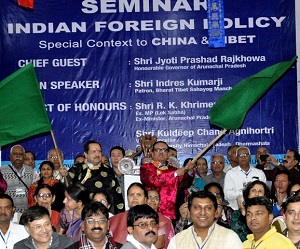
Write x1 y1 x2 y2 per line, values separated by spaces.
121 204 159 249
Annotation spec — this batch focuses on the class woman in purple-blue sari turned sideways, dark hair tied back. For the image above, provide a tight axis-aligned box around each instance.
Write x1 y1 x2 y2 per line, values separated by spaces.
57 183 90 241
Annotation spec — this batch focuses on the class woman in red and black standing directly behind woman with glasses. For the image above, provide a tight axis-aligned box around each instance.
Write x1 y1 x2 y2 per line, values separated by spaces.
28 161 65 212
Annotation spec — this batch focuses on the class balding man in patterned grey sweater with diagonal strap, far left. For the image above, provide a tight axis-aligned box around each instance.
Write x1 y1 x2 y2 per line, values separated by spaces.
0 145 34 213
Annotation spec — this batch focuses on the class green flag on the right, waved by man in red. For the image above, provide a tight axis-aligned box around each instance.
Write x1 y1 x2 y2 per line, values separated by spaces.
209 56 297 130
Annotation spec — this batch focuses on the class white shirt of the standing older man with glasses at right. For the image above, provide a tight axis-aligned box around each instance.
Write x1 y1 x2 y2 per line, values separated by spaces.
224 166 267 210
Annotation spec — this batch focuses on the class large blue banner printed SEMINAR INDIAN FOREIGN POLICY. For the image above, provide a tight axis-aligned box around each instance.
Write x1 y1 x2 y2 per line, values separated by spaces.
0 0 298 165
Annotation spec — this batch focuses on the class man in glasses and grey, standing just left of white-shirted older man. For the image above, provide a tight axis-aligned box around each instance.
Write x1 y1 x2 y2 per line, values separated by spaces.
203 154 225 188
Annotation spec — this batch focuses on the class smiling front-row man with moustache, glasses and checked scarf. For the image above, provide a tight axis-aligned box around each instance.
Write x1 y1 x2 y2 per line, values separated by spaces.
76 201 116 249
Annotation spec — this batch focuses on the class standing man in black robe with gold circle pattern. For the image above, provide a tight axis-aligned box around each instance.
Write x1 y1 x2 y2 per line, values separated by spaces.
69 140 124 214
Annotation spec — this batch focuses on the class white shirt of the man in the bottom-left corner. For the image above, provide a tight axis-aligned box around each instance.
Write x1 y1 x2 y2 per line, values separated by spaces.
0 222 29 249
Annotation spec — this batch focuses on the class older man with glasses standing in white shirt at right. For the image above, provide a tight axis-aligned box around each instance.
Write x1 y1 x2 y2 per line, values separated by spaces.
224 147 266 210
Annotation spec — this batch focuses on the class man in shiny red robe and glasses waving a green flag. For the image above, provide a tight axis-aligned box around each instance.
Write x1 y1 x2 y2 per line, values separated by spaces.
140 141 194 220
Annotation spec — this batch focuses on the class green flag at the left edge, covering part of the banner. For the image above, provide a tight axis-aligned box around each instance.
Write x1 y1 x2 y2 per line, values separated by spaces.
0 64 51 146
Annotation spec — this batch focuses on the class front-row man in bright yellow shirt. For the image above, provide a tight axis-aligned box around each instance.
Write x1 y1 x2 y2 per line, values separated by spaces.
243 196 295 249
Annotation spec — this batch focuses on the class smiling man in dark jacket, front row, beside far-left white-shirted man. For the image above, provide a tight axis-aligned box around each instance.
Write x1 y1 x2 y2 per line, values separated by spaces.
14 206 78 249
